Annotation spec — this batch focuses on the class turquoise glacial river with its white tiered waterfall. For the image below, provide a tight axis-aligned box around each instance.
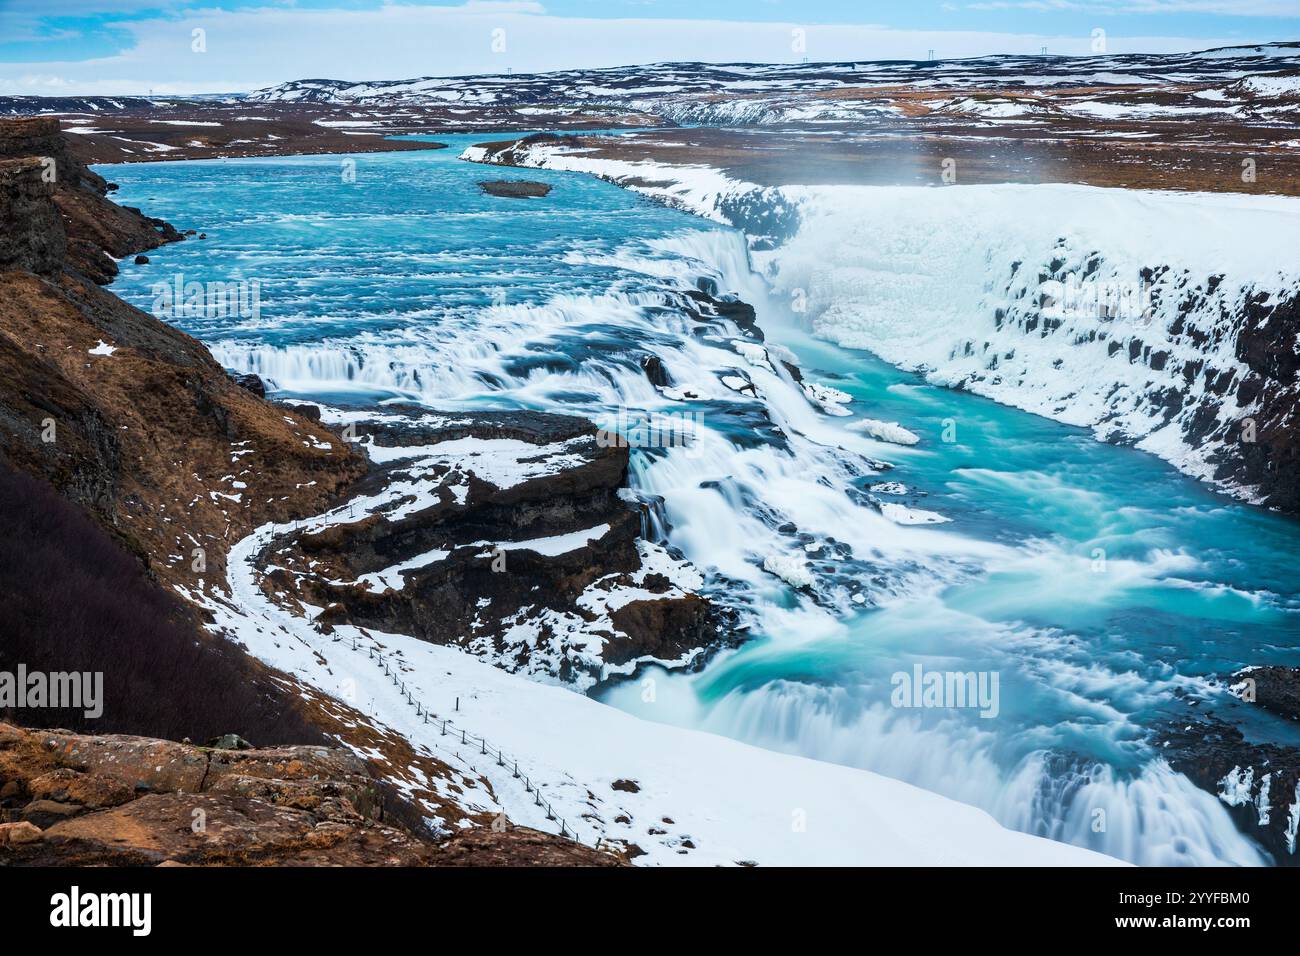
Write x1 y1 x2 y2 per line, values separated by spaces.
101 134 1300 864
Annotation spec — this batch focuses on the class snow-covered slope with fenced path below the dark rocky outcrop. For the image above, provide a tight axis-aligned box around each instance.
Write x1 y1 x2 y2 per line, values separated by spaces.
202 511 1117 866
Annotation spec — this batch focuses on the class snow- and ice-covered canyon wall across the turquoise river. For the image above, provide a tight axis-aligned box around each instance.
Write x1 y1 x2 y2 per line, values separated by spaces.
463 140 1300 510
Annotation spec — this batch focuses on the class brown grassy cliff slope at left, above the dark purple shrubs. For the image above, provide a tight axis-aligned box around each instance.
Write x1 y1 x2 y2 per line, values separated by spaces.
0 118 364 589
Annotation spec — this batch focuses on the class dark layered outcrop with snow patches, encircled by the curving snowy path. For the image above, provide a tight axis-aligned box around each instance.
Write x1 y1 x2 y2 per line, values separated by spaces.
245 407 729 685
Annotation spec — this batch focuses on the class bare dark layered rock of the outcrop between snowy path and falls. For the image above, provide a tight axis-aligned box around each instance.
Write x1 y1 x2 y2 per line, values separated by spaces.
263 406 729 680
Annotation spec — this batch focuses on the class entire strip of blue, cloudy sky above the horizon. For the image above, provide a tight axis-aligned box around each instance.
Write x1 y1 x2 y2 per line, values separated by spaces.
0 0 1300 94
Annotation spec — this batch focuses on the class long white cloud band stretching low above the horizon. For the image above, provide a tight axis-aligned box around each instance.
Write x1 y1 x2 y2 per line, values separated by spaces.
0 0 1258 95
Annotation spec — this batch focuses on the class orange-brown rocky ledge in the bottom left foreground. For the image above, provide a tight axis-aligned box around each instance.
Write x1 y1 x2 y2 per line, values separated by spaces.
0 723 624 866
